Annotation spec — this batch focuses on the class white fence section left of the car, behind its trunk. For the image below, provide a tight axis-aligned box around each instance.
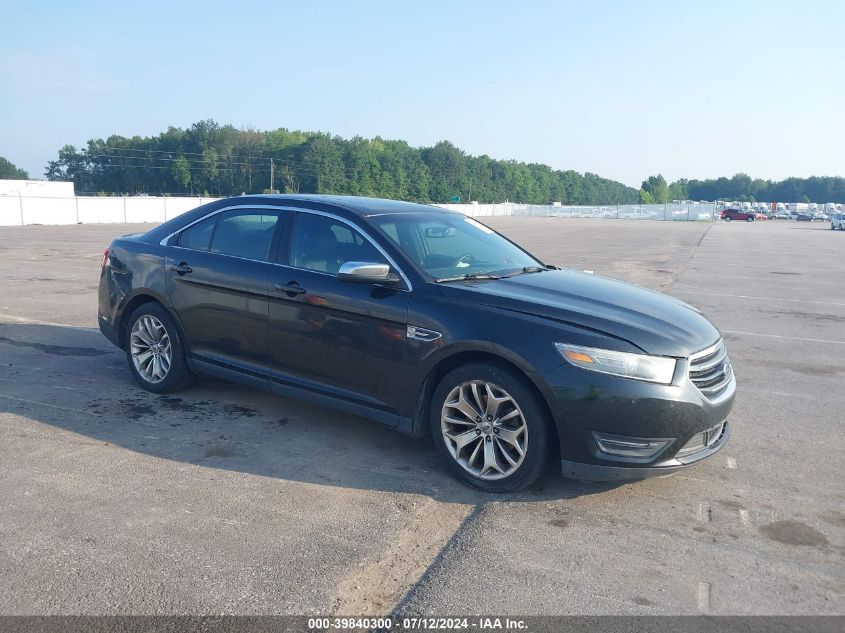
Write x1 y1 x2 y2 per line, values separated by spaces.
0 195 217 226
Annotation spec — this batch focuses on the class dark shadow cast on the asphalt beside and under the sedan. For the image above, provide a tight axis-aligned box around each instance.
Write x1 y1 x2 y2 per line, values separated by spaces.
0 323 619 503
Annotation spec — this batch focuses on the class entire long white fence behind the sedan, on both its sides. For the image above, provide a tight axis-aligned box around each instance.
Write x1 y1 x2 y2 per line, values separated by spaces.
0 195 716 226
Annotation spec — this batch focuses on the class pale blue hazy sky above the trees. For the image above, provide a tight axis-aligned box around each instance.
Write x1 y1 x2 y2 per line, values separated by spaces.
0 0 845 187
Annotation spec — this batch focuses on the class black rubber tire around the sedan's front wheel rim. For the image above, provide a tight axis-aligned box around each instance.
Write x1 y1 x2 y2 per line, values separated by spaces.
429 363 554 493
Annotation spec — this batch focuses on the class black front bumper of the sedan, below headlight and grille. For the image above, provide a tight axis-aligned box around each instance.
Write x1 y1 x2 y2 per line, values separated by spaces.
544 356 736 481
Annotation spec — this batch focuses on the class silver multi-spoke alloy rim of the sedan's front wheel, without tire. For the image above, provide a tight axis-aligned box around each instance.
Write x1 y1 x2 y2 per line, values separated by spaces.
440 380 528 480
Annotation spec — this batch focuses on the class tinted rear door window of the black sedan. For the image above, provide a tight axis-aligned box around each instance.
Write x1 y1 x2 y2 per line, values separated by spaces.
211 211 279 261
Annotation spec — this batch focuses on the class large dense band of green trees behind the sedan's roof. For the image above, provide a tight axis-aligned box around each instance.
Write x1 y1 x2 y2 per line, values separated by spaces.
45 121 637 204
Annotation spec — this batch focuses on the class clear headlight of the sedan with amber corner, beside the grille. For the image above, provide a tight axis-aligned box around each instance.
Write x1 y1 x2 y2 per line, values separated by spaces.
555 343 676 385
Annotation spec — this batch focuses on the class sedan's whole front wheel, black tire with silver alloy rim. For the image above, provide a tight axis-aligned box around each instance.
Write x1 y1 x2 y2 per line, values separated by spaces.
431 363 553 492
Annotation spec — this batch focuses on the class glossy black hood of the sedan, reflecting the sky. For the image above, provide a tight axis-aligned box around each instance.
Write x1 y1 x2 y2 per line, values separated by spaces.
440 270 719 357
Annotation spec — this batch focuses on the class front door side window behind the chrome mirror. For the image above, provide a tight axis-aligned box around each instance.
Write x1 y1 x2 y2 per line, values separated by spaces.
287 212 388 275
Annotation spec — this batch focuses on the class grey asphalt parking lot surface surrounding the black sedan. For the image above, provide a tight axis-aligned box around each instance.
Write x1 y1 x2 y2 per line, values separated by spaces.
0 218 845 615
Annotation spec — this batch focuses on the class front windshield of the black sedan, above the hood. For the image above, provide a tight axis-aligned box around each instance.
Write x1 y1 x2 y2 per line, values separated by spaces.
372 214 543 281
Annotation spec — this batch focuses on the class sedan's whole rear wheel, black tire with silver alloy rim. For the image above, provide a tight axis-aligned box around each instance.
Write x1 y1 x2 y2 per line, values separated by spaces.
126 302 192 393
